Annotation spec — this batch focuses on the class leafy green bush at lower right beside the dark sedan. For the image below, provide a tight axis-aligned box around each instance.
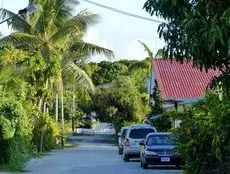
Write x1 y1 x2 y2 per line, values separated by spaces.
171 94 230 174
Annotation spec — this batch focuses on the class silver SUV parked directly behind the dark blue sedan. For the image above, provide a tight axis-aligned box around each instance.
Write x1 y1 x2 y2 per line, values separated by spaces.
123 124 157 162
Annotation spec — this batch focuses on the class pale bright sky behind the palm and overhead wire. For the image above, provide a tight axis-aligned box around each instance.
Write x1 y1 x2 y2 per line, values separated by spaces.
0 0 164 62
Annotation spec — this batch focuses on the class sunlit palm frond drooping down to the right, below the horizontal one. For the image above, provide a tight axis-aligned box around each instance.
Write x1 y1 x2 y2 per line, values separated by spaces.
62 59 94 91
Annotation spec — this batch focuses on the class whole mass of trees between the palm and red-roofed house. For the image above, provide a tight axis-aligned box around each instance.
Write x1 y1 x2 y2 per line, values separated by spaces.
85 59 153 130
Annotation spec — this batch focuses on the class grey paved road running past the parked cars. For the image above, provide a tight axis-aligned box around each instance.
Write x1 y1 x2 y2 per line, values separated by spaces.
0 137 182 174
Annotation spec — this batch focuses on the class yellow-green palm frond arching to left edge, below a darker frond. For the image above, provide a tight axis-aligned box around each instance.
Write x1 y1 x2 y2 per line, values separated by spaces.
0 32 42 49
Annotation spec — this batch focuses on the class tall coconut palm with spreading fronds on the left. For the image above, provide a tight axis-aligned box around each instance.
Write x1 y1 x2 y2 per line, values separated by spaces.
0 0 113 150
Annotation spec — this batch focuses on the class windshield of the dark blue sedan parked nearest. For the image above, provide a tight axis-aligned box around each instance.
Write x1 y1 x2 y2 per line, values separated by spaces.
146 135 176 146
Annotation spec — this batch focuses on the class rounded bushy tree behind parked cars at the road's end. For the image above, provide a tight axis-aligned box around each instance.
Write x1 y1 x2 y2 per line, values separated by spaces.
92 76 149 124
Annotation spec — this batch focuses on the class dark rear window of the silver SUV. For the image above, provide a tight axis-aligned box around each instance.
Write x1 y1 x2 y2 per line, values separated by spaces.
129 128 155 139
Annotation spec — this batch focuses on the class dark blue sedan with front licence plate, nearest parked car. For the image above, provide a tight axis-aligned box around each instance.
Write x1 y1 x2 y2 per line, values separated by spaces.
140 133 182 169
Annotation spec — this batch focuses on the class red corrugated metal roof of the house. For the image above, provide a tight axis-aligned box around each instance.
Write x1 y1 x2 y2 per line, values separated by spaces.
153 59 220 99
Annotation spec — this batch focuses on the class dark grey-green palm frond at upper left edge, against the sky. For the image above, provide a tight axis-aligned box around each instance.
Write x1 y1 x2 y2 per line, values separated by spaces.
0 8 31 33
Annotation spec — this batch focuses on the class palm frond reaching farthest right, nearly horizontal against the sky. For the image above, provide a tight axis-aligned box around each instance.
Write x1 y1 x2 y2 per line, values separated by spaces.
70 41 114 59
